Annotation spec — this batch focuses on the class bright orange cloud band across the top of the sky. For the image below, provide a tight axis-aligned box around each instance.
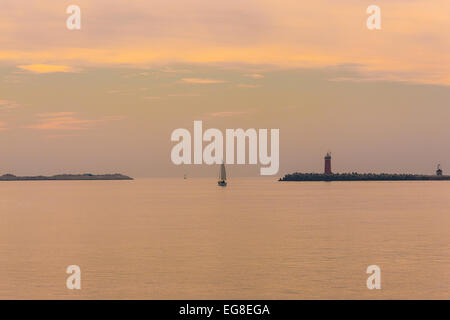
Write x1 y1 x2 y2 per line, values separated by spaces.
0 0 450 84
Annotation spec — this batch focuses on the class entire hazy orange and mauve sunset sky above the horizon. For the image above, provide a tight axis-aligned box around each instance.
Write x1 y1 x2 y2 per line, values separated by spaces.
0 0 450 177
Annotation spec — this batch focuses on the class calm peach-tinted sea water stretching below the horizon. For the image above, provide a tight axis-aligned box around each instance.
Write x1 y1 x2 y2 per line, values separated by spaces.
0 179 450 299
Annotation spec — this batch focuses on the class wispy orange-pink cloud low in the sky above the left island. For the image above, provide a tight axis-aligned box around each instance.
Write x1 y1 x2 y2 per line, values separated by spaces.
26 112 120 131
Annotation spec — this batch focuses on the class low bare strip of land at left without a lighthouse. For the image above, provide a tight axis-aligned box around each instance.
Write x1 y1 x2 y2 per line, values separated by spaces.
0 173 133 181
